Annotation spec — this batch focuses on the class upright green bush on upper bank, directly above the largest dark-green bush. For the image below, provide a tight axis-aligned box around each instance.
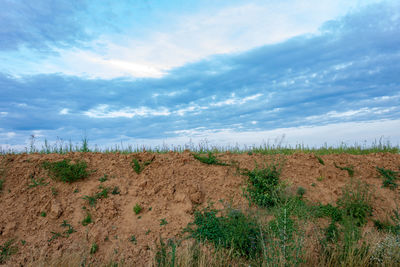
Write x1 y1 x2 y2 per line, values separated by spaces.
244 160 282 208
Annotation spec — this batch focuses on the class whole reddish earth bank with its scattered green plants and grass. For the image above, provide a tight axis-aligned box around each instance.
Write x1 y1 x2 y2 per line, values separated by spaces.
0 143 400 266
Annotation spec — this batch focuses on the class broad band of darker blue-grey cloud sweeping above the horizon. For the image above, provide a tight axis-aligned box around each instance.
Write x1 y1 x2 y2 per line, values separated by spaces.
0 1 400 149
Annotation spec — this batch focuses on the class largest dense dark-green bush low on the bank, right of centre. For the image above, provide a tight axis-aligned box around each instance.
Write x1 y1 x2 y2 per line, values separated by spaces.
185 207 262 257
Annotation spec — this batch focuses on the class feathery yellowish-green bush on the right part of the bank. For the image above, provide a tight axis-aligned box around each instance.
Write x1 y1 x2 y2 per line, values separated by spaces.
337 180 372 226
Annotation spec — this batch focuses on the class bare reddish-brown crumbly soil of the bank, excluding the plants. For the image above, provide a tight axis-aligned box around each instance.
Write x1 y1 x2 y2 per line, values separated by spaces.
0 151 400 266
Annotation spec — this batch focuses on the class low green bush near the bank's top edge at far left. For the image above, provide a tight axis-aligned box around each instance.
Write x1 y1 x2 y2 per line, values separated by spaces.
42 159 90 183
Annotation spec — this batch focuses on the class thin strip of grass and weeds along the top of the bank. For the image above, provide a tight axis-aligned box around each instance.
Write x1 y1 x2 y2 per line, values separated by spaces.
0 138 400 155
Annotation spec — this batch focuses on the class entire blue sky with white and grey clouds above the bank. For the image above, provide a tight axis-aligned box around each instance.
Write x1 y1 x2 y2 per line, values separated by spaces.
0 0 400 149
